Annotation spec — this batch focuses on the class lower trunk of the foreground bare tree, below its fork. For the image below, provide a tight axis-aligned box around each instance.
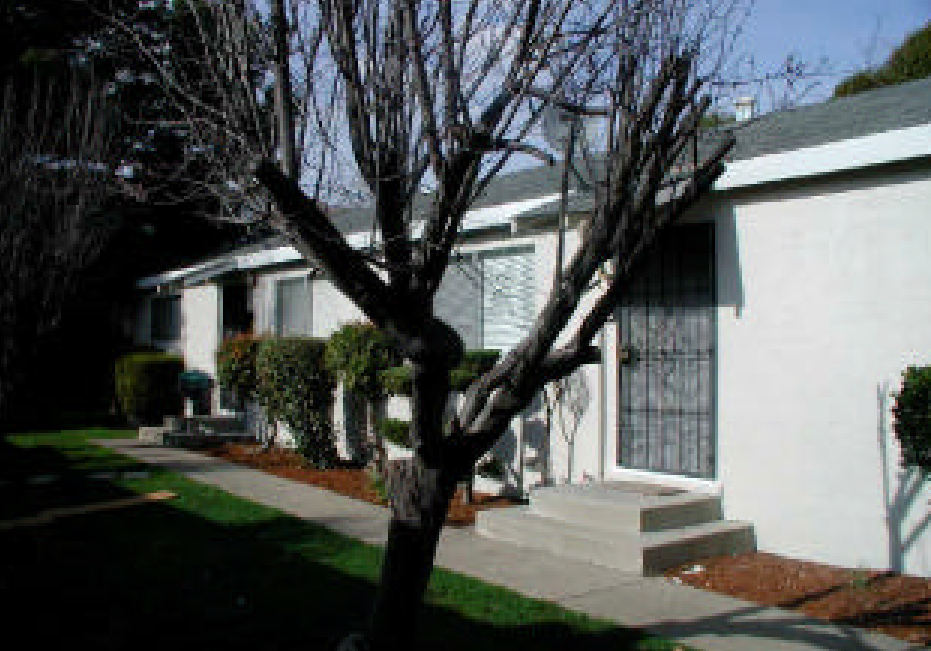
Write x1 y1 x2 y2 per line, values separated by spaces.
369 457 457 651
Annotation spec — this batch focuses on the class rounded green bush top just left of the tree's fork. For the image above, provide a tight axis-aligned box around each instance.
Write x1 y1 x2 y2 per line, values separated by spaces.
325 323 400 400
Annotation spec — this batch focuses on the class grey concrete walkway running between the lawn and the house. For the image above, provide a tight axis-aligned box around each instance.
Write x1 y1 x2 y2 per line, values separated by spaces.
101 439 921 651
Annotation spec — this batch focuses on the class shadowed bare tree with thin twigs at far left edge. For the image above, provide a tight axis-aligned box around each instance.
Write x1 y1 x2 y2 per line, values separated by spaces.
0 72 117 426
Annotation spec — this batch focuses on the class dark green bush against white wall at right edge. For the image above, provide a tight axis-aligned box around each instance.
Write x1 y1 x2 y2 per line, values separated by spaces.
892 366 931 471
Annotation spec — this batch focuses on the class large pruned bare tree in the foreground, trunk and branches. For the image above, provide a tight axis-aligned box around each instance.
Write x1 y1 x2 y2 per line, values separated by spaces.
100 0 737 649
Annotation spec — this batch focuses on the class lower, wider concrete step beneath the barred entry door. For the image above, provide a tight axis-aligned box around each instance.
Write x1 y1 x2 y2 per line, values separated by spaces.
475 506 753 574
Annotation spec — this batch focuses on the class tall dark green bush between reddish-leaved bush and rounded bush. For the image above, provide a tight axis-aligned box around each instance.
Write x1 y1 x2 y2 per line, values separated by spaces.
255 337 336 468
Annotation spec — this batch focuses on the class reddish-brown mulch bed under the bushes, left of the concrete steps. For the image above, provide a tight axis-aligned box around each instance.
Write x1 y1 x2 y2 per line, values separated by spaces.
202 443 520 527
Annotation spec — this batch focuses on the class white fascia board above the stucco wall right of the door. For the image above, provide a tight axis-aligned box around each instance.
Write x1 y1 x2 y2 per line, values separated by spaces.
714 124 931 190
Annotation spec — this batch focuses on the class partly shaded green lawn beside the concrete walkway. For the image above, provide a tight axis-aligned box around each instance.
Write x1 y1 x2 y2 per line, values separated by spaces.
0 429 681 651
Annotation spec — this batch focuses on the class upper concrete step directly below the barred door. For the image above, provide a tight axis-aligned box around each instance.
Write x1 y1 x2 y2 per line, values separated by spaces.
530 484 721 532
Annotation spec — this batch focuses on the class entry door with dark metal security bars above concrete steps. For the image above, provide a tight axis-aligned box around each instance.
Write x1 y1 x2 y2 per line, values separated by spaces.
617 224 716 479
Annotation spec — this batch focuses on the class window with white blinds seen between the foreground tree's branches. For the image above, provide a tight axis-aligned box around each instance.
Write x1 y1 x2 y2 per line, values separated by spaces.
434 247 534 351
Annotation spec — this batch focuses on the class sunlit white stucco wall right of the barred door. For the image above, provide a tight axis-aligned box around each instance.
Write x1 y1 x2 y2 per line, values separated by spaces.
713 167 931 575
